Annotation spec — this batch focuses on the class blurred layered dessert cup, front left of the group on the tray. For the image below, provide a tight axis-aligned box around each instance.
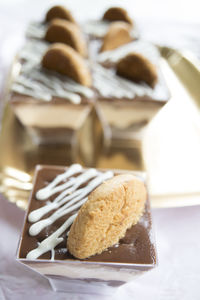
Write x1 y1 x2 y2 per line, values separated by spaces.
10 41 94 144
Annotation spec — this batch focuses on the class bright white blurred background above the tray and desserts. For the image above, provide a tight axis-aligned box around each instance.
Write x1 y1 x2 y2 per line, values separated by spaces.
0 0 200 93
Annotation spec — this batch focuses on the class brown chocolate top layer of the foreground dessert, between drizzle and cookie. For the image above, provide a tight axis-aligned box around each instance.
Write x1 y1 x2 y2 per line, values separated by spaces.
19 166 156 264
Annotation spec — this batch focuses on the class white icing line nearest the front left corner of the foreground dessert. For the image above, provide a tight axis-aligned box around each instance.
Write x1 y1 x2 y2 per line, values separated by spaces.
26 214 77 260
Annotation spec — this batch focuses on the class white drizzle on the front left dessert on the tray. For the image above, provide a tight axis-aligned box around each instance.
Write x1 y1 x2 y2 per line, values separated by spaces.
11 40 93 104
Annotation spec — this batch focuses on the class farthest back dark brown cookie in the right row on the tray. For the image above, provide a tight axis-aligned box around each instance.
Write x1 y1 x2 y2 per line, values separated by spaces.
103 7 133 25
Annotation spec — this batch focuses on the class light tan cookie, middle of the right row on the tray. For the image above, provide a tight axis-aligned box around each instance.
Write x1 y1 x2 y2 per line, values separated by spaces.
100 21 133 52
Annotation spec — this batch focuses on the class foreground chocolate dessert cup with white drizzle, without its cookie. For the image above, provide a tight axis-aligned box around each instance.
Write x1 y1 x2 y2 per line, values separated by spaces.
18 164 156 293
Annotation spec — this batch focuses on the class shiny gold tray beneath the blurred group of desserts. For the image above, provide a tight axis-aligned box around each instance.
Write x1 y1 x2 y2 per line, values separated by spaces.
0 48 200 209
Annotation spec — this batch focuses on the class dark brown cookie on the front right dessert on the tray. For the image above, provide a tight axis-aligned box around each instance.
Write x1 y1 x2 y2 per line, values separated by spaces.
116 53 158 88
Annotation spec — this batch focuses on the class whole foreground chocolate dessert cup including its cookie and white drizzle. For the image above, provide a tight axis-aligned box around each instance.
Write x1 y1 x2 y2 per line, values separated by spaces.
18 164 156 293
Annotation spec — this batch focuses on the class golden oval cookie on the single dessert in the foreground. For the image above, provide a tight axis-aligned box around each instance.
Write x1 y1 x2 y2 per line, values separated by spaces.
67 174 147 259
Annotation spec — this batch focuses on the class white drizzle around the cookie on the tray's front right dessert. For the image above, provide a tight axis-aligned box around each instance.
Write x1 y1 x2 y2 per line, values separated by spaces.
92 40 169 101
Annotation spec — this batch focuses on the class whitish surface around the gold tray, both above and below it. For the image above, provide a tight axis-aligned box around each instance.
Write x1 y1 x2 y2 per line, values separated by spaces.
0 0 200 300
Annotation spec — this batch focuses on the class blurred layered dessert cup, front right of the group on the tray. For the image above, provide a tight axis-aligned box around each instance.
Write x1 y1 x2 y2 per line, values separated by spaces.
93 40 169 146
